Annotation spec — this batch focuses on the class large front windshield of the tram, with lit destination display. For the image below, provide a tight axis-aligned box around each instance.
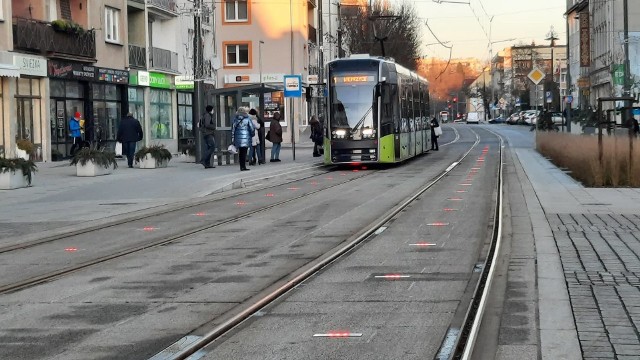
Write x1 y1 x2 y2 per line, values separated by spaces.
330 72 376 133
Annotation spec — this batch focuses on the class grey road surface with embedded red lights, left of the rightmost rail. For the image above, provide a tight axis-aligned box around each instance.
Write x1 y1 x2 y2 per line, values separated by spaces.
0 125 508 360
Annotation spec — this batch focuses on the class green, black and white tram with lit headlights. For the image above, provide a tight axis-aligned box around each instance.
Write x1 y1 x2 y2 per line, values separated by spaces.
324 55 431 165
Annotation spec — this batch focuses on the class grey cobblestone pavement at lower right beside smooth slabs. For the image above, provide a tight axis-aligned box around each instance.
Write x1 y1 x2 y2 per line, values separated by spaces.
547 214 640 360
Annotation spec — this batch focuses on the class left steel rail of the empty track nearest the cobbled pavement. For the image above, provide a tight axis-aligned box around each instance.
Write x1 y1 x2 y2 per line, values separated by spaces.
159 131 480 360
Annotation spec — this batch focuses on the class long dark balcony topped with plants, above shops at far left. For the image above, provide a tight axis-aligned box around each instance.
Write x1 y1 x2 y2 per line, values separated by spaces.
13 18 96 62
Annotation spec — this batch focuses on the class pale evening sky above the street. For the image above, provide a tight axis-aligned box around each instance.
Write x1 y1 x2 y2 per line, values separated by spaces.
410 0 566 61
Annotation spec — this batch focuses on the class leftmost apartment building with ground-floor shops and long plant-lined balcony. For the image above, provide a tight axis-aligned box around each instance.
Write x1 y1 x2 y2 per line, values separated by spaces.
0 0 129 160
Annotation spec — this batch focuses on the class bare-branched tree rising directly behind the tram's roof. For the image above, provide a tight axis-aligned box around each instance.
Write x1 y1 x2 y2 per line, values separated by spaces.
341 0 420 70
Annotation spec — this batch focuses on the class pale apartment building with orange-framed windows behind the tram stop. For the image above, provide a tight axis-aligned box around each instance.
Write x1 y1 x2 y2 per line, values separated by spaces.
213 0 320 143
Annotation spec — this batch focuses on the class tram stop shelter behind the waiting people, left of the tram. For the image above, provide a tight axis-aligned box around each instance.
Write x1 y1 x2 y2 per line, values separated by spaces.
204 84 283 159
